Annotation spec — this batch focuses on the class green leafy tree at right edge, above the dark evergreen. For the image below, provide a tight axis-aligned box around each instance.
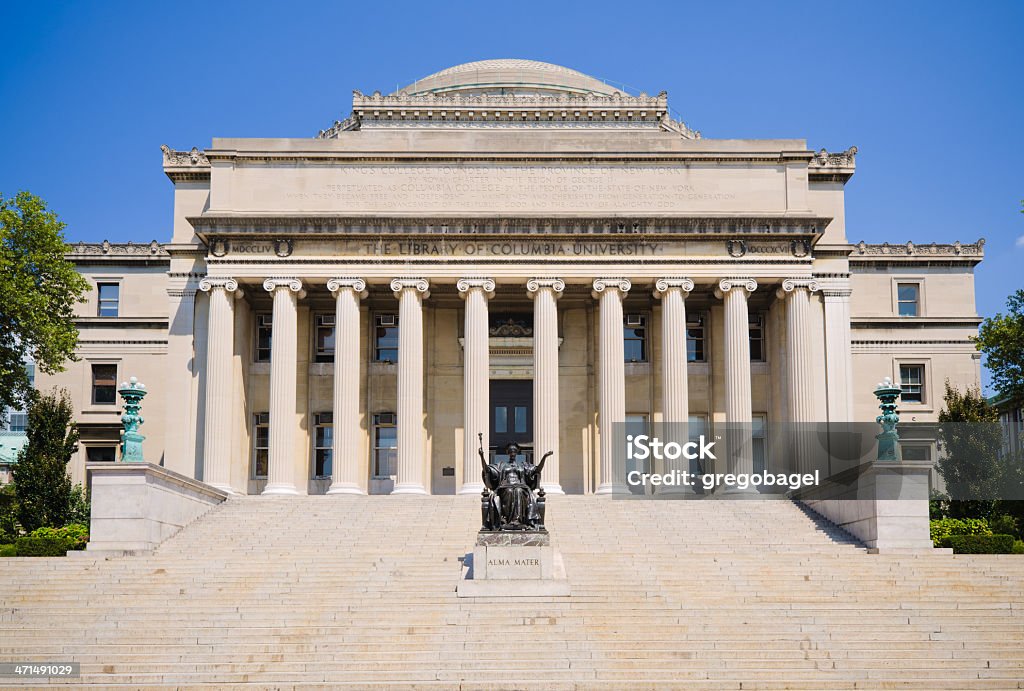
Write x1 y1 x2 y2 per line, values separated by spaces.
975 289 1024 403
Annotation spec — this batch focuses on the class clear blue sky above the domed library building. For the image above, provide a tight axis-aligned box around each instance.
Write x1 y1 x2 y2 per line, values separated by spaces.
0 0 1024 323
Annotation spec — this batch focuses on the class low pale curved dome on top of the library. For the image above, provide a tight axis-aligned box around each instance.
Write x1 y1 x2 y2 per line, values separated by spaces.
396 58 615 95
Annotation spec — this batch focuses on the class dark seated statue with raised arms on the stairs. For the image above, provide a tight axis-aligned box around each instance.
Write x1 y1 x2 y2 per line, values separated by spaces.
479 434 553 530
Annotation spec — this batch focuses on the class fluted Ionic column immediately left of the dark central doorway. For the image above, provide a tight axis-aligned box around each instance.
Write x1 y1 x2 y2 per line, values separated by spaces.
462 278 495 494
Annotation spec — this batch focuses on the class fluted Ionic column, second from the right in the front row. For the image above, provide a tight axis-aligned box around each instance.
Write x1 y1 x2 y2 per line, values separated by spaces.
715 278 758 491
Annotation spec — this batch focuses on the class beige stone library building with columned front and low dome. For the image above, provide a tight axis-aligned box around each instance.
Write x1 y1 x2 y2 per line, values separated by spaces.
39 60 982 493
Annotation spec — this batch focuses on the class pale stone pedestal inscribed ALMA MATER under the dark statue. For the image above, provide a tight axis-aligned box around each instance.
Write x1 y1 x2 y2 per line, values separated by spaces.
456 530 569 598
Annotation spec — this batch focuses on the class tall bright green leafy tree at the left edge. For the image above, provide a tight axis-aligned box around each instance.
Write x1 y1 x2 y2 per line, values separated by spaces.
0 191 88 422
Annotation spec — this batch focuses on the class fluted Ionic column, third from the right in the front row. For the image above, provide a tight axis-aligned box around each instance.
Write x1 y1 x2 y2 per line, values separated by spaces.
654 277 693 491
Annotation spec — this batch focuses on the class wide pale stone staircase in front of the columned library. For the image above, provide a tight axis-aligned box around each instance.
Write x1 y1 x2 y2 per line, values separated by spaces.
0 496 1024 691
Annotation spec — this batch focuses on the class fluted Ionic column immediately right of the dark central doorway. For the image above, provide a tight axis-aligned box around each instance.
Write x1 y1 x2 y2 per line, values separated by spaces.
526 278 565 494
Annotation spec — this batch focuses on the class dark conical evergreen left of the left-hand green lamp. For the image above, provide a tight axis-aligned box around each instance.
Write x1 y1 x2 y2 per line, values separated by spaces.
13 390 78 532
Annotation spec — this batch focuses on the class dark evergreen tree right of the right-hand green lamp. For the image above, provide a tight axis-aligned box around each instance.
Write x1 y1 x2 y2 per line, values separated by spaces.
936 380 1021 518
